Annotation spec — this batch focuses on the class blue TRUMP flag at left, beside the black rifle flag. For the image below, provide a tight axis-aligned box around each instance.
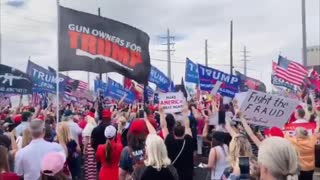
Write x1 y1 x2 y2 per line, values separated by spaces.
27 61 66 93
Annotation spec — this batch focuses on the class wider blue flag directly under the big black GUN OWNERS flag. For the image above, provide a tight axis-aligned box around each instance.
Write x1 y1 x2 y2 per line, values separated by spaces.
106 78 135 104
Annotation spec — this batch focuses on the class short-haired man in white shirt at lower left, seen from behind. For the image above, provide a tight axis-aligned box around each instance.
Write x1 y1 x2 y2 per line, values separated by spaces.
14 119 65 180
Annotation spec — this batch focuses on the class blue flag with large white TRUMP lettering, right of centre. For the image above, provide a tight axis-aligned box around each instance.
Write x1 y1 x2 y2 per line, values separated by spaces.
198 64 240 98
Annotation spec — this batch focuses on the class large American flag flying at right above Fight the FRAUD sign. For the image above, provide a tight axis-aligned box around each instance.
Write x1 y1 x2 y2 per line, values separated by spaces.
274 56 308 86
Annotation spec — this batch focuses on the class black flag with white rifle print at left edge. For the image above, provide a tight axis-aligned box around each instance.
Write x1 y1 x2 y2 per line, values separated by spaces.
0 64 32 94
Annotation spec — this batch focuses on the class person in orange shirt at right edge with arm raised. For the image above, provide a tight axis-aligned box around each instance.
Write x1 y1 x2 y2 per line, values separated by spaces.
285 127 317 180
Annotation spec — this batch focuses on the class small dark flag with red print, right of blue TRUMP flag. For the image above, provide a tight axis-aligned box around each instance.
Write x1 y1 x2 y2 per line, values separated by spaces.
236 71 266 92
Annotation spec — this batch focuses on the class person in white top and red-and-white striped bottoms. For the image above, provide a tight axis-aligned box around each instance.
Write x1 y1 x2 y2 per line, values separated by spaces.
82 116 97 180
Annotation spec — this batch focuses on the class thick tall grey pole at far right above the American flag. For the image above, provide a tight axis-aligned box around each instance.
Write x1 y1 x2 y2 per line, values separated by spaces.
301 0 307 66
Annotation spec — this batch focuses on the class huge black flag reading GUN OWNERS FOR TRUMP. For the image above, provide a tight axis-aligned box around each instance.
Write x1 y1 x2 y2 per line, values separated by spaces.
59 6 151 84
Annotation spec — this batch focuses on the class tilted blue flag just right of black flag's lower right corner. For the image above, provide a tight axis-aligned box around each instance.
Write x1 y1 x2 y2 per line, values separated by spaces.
149 66 171 91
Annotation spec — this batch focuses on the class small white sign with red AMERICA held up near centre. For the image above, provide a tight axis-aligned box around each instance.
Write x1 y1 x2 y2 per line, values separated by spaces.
159 92 185 113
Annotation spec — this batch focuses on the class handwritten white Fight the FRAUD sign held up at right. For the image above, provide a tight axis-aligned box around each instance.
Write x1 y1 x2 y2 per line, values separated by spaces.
235 90 299 128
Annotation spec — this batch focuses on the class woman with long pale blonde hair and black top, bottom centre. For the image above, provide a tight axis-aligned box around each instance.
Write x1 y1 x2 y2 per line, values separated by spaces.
134 134 179 180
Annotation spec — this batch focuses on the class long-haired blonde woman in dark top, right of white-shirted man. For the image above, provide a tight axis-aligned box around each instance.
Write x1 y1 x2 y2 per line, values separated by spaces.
57 122 81 179
